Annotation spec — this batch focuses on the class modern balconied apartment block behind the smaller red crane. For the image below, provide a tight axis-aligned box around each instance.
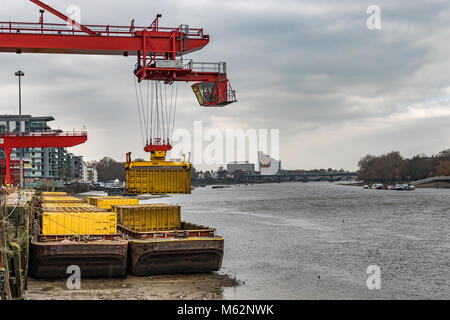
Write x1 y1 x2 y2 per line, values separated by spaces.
0 115 83 181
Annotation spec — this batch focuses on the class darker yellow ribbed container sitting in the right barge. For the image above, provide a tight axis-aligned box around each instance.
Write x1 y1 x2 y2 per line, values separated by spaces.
114 204 181 232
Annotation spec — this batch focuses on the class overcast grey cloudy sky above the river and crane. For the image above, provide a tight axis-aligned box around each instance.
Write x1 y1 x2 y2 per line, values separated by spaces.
0 0 450 170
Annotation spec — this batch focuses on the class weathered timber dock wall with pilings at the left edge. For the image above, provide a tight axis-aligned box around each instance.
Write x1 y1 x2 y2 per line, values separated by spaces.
0 190 36 300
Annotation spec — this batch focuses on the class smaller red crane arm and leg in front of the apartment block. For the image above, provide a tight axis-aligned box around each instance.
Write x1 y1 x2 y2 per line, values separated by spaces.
0 131 87 186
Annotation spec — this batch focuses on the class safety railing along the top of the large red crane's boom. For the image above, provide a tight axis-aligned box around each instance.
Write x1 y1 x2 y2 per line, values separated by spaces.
0 22 204 39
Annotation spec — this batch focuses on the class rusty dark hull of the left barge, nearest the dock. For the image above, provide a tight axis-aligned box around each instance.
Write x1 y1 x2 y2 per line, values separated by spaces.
30 240 128 279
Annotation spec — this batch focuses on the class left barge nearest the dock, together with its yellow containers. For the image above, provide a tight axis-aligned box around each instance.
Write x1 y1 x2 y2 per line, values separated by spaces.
30 192 128 278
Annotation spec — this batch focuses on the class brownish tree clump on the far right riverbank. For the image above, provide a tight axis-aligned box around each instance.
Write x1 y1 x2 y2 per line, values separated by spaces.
358 149 450 182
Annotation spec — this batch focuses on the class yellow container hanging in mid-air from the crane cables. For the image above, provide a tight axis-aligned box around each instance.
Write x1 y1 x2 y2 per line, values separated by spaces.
125 166 191 195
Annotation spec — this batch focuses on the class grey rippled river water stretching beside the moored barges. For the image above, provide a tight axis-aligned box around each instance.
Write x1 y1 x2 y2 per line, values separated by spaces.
144 182 450 299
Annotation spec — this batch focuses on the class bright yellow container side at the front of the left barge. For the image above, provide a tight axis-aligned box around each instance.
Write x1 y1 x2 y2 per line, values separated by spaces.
42 212 117 235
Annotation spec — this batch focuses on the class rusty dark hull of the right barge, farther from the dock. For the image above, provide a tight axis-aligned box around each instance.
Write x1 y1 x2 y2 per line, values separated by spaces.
118 222 224 276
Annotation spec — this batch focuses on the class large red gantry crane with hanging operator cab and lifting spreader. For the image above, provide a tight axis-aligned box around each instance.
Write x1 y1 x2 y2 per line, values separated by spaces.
0 0 236 158
